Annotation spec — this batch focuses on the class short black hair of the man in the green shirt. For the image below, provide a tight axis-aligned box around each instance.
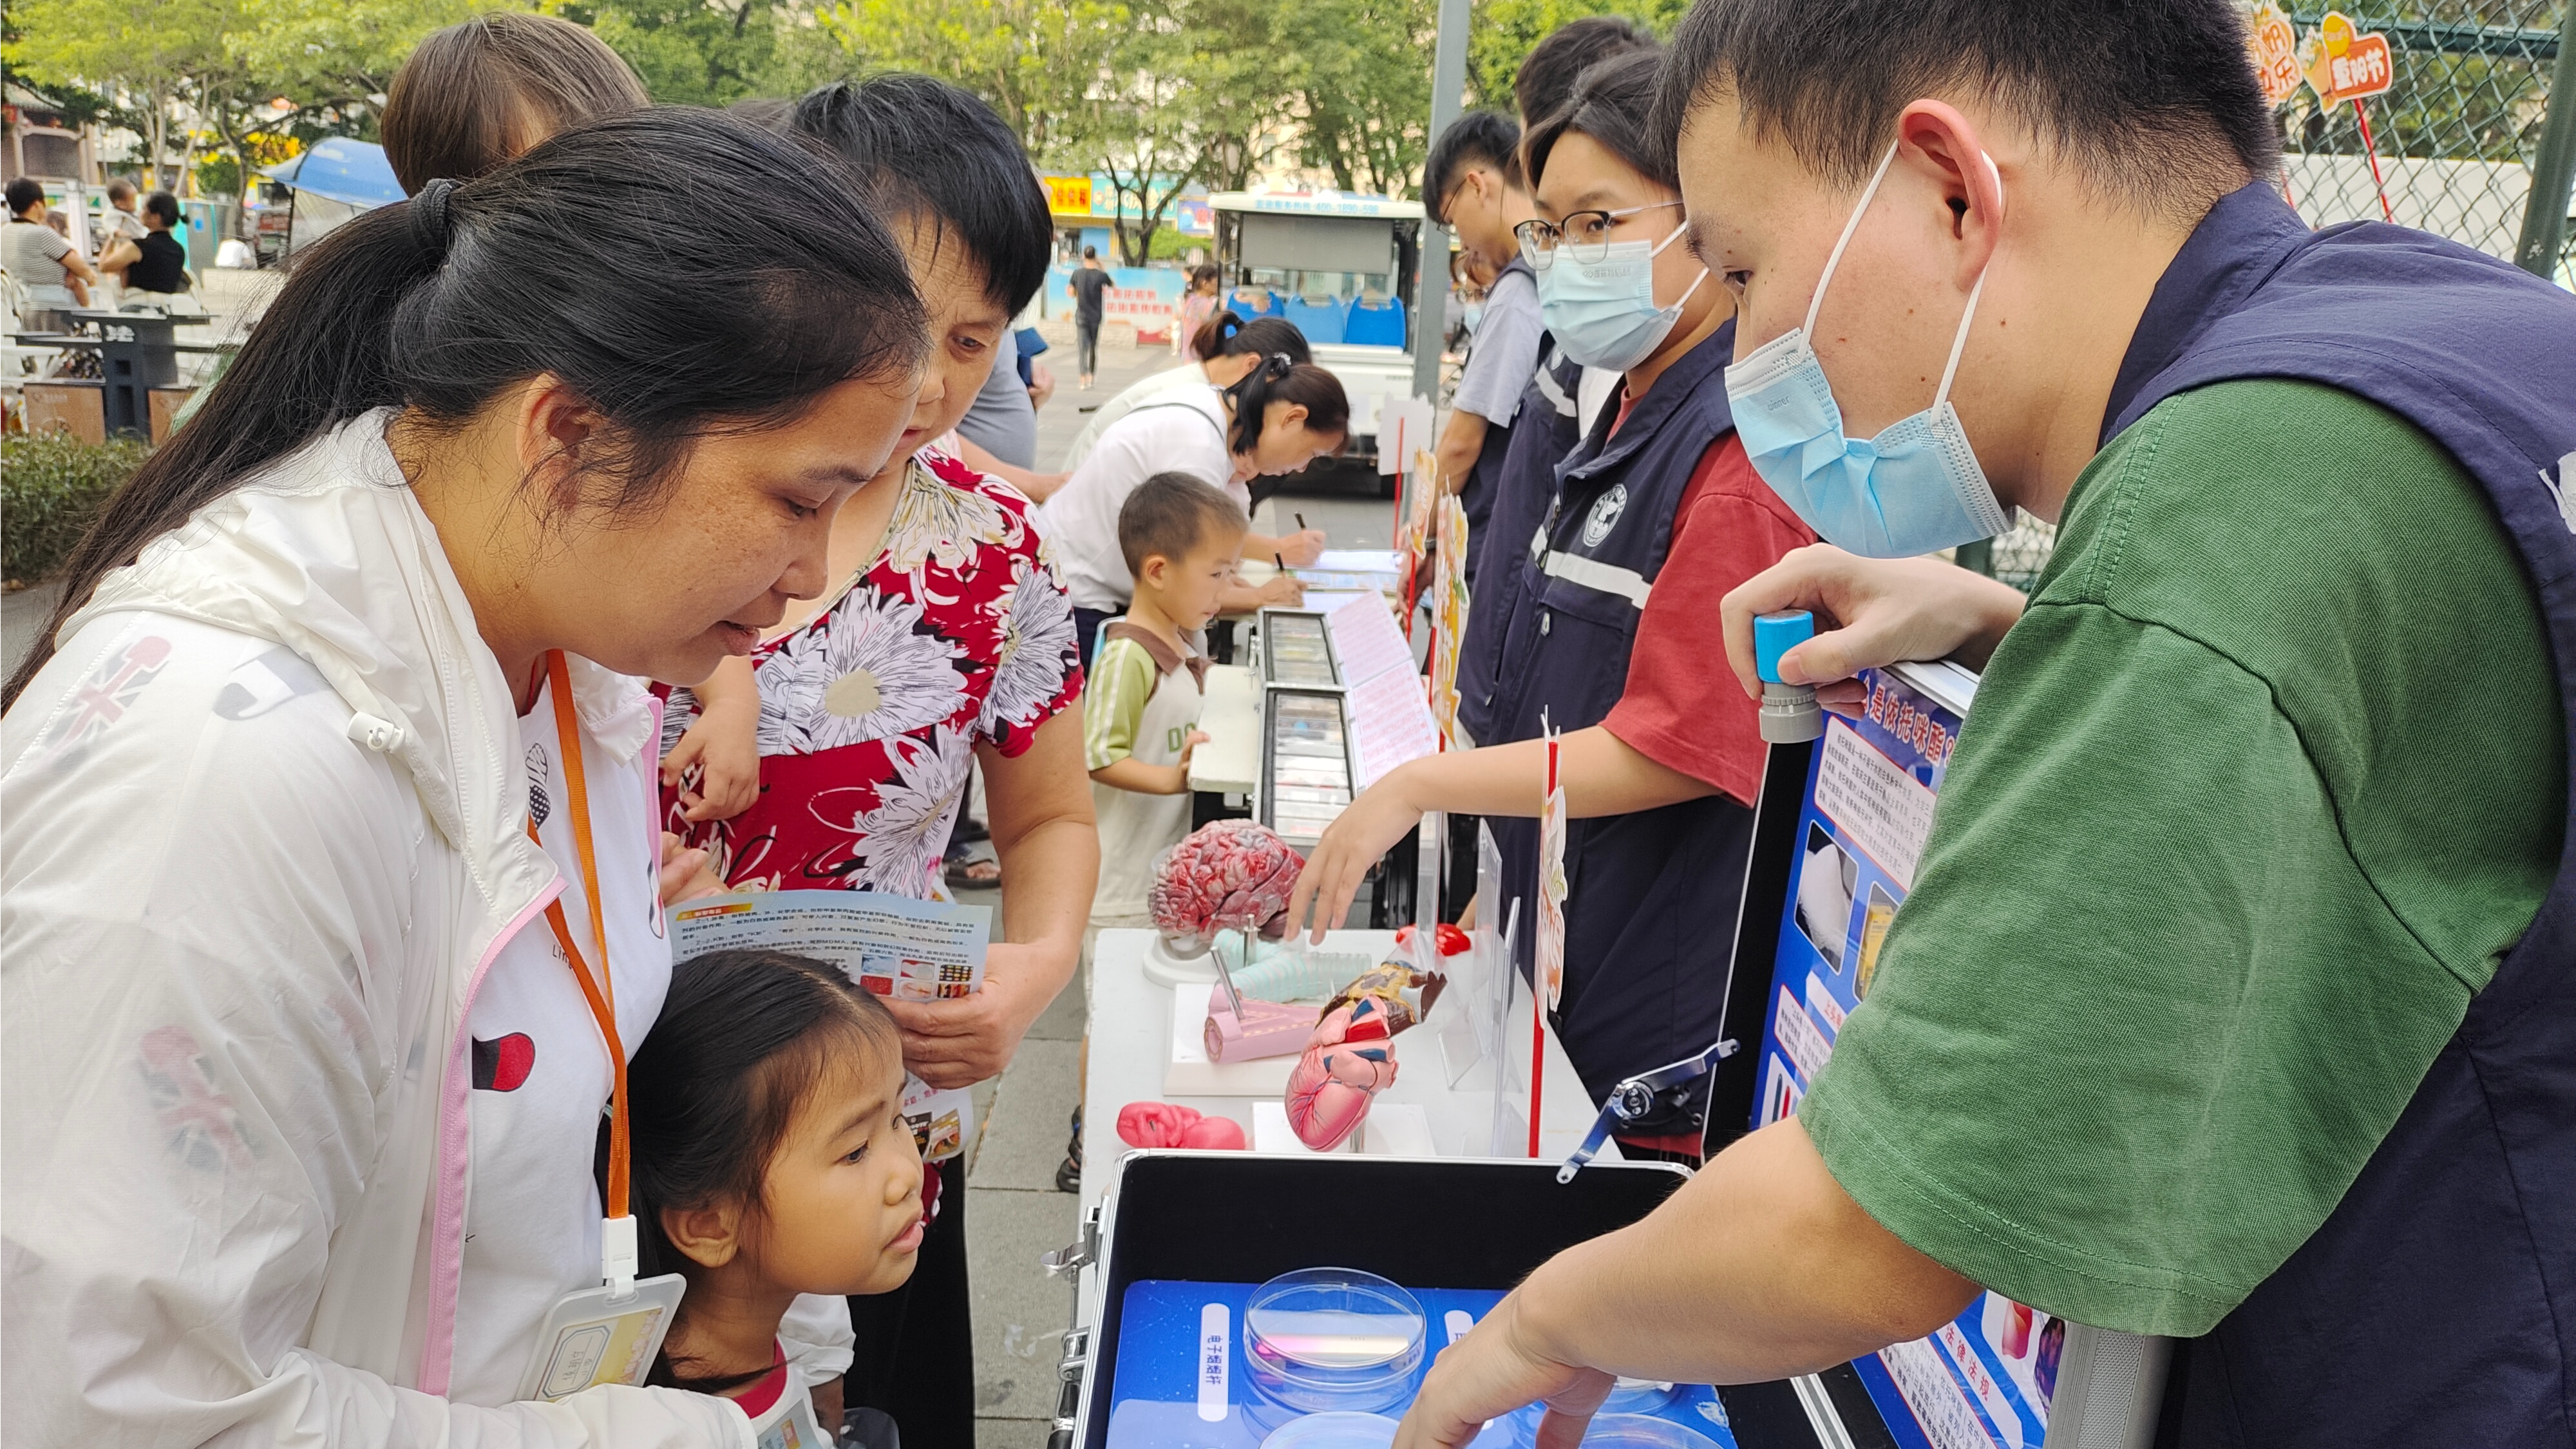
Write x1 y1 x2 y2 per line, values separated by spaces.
1656 0 2280 216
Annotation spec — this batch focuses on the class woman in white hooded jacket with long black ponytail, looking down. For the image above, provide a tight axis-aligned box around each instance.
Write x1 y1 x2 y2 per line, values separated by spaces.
0 111 925 1449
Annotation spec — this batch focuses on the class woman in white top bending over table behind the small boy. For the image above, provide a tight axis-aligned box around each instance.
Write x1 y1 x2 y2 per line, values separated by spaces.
1038 353 1350 660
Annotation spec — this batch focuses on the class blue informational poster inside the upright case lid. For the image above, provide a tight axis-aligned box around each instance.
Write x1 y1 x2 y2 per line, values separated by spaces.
1752 665 2066 1449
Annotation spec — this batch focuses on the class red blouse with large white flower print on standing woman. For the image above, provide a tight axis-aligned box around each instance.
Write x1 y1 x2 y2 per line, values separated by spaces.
662 449 1082 900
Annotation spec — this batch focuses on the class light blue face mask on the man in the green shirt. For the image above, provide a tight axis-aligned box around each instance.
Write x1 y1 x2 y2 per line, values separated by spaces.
1726 147 2007 560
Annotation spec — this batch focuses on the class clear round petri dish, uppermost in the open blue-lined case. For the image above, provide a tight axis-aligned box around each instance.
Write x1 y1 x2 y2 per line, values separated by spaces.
1244 1269 1427 1416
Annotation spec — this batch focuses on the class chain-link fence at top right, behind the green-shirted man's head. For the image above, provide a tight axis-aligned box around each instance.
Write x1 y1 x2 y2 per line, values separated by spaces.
2277 0 2576 286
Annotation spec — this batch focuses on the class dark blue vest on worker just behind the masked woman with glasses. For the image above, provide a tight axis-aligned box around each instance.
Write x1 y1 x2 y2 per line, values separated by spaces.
1458 340 1584 743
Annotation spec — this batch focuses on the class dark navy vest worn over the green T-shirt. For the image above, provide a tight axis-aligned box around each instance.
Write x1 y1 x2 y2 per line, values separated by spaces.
2102 183 2576 1449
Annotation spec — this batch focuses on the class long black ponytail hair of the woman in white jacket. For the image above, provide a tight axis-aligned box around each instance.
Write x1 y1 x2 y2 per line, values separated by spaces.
0 106 927 709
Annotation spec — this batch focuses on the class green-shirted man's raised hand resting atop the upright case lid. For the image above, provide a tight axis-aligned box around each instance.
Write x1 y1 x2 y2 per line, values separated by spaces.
1718 544 2022 714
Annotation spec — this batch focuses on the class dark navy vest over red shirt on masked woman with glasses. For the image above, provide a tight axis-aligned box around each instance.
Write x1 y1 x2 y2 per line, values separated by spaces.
1489 322 1752 1135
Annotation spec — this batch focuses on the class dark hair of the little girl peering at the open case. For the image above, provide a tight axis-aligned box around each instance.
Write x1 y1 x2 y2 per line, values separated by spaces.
623 951 904 1392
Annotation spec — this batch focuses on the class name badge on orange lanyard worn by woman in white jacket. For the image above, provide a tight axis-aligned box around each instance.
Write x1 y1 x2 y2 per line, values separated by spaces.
518 650 690 1392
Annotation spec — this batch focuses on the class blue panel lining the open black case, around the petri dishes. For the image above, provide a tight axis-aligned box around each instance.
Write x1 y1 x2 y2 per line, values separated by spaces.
1108 1279 1736 1449
